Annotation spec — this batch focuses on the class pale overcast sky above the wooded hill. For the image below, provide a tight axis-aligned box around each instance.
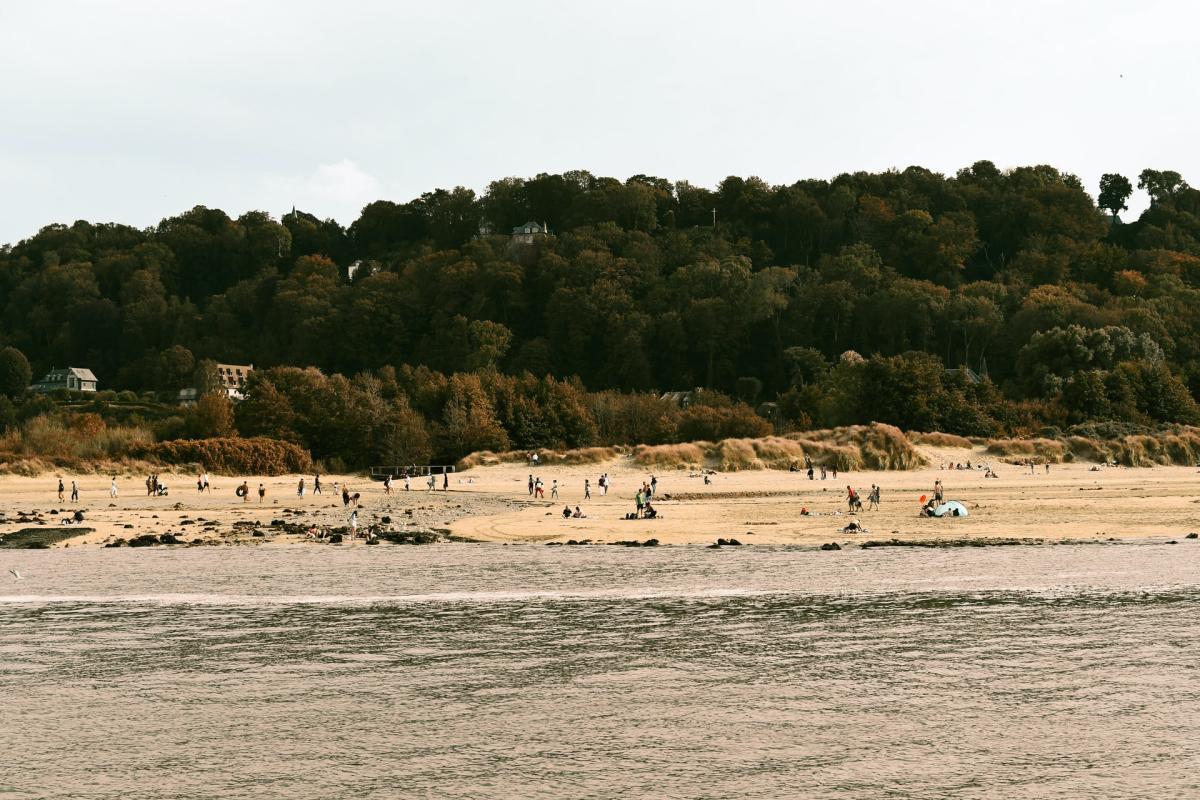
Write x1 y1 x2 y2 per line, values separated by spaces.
0 0 1200 242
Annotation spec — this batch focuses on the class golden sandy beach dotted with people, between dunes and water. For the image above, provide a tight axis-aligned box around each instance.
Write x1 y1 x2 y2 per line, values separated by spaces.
0 447 1200 547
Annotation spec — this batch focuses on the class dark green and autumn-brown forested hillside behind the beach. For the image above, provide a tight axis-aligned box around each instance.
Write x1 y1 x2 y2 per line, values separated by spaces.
0 162 1200 456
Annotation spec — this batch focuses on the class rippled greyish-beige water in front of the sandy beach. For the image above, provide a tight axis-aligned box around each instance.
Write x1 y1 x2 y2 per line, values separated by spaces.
0 541 1200 800
